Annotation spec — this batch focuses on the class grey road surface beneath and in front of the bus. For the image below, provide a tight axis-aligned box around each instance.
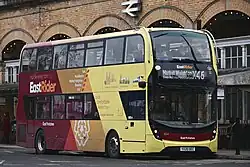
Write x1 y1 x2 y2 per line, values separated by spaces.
0 145 250 167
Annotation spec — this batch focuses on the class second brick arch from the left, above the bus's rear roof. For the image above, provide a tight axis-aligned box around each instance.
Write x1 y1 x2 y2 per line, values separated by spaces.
37 22 81 42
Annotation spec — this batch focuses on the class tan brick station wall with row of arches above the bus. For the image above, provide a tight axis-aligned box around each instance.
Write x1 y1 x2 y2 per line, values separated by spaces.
0 0 250 57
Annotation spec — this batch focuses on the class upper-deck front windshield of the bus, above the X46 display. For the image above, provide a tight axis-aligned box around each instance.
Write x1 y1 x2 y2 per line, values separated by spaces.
151 31 211 62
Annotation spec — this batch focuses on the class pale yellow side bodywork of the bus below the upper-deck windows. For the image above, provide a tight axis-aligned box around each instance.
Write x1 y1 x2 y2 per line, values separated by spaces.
89 63 146 153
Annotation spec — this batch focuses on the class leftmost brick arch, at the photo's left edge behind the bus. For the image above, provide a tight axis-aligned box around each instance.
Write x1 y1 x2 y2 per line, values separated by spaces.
0 28 36 60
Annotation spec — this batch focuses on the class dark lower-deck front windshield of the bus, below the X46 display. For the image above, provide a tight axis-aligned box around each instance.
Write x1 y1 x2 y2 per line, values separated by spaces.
149 87 216 126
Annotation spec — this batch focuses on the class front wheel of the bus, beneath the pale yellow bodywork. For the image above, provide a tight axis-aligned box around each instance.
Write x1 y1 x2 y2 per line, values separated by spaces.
106 132 120 158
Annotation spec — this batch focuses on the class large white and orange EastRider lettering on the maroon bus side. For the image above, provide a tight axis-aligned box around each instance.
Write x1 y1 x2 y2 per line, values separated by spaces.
30 80 56 93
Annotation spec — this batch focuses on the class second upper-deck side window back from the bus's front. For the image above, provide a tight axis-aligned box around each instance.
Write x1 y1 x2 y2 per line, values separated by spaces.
104 38 124 64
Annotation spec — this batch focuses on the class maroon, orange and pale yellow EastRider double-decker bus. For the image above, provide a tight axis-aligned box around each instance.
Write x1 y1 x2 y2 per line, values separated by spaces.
16 27 218 158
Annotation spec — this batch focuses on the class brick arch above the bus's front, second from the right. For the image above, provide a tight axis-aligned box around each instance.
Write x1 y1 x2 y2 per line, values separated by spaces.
138 6 193 28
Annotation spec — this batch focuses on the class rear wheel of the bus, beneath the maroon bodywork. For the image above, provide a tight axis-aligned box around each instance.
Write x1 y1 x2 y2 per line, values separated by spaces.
35 130 46 154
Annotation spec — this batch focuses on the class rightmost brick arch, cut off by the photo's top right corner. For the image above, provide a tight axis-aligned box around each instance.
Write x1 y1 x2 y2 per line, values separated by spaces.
195 0 250 27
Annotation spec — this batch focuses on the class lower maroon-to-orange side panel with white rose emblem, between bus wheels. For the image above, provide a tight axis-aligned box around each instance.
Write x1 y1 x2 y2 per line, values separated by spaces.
32 120 105 152
